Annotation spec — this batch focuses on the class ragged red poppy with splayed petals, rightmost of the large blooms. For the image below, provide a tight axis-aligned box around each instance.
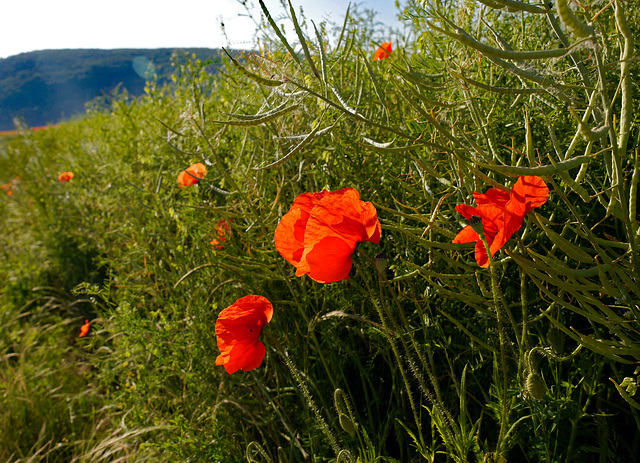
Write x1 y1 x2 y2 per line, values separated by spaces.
453 176 549 268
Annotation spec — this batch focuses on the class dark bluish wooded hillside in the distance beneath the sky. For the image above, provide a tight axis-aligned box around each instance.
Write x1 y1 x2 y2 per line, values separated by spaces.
0 48 225 131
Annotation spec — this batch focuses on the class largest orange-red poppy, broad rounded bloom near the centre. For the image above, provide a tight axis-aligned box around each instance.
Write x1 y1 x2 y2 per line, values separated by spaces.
275 188 381 283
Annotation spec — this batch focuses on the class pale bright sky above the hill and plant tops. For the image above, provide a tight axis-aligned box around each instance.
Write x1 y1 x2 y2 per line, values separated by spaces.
0 0 400 58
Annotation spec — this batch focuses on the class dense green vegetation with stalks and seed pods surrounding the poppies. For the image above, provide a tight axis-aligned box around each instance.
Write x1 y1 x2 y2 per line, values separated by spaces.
0 0 640 463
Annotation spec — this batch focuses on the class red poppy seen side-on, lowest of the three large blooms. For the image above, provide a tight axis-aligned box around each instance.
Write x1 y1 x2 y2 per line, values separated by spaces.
216 295 273 374
